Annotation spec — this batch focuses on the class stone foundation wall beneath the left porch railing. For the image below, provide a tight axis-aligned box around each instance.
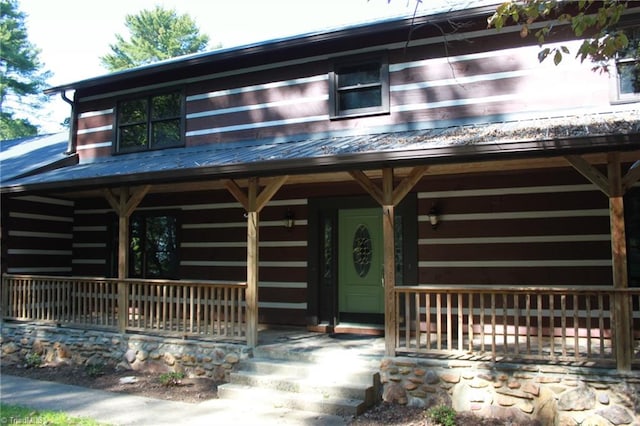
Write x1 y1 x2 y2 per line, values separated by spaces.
0 322 251 381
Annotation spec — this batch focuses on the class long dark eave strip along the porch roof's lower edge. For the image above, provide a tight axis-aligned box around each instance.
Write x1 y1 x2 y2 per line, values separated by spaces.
0 133 640 193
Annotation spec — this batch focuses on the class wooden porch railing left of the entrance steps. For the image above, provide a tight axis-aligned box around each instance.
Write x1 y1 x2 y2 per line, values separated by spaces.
2 274 246 341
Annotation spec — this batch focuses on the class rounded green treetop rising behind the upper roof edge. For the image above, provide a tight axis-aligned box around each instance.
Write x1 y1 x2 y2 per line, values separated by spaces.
100 6 209 71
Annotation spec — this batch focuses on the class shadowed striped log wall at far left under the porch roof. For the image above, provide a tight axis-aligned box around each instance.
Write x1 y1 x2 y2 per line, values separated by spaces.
2 196 73 275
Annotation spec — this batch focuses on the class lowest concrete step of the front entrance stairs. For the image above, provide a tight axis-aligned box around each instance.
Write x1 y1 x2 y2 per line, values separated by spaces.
218 383 368 416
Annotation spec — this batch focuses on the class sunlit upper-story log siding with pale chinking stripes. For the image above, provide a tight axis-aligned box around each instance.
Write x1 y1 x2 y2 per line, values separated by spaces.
72 30 609 160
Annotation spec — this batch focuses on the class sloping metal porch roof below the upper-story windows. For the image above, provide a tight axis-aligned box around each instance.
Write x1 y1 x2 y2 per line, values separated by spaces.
1 105 640 192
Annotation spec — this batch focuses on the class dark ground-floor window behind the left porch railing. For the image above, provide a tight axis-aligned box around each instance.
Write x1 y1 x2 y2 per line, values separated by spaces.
129 215 178 278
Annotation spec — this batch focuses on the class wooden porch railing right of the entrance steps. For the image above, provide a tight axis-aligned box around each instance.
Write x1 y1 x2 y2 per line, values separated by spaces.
395 286 640 362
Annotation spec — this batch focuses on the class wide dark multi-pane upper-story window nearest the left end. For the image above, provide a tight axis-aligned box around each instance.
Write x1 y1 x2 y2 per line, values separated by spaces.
117 90 184 152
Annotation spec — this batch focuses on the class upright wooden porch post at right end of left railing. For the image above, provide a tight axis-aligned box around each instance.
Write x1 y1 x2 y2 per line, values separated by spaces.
245 178 259 347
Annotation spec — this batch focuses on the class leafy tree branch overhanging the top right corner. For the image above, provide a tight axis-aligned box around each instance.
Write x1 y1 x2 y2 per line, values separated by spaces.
489 0 640 71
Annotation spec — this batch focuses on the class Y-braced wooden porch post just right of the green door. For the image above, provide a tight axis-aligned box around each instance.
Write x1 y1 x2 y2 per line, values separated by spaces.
349 166 428 356
